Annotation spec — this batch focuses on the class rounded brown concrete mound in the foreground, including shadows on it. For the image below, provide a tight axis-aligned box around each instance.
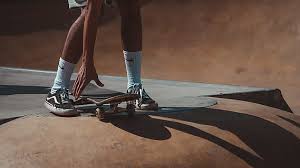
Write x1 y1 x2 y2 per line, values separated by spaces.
0 100 300 168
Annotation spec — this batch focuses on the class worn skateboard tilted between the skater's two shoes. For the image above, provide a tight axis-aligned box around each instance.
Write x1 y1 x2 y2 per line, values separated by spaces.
74 94 139 120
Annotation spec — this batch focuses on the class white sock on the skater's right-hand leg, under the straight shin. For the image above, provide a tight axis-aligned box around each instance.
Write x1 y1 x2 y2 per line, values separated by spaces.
123 51 142 89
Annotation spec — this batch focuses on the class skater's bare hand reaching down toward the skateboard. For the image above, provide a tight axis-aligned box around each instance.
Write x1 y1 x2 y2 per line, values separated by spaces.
72 64 104 99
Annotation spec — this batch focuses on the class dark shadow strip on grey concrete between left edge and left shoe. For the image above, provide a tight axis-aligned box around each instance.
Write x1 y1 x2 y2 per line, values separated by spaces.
0 85 50 95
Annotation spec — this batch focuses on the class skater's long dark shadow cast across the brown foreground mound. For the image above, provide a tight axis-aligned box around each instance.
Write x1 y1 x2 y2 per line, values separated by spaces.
110 108 300 167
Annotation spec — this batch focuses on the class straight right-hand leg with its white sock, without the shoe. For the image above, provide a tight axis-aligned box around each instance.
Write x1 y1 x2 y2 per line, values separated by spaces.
117 0 142 89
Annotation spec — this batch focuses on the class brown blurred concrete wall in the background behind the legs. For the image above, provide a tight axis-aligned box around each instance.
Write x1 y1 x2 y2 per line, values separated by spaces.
0 0 300 110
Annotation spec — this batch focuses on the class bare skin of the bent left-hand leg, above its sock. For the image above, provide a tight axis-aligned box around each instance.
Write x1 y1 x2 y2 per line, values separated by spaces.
61 8 86 64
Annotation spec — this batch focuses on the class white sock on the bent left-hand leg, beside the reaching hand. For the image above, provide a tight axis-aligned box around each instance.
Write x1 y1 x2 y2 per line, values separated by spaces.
51 58 75 94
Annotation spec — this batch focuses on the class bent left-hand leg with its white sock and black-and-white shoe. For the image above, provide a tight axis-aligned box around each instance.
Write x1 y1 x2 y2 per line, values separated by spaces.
44 6 85 116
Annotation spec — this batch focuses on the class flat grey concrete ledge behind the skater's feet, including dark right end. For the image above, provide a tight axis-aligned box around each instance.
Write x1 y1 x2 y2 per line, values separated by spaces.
0 67 291 119
